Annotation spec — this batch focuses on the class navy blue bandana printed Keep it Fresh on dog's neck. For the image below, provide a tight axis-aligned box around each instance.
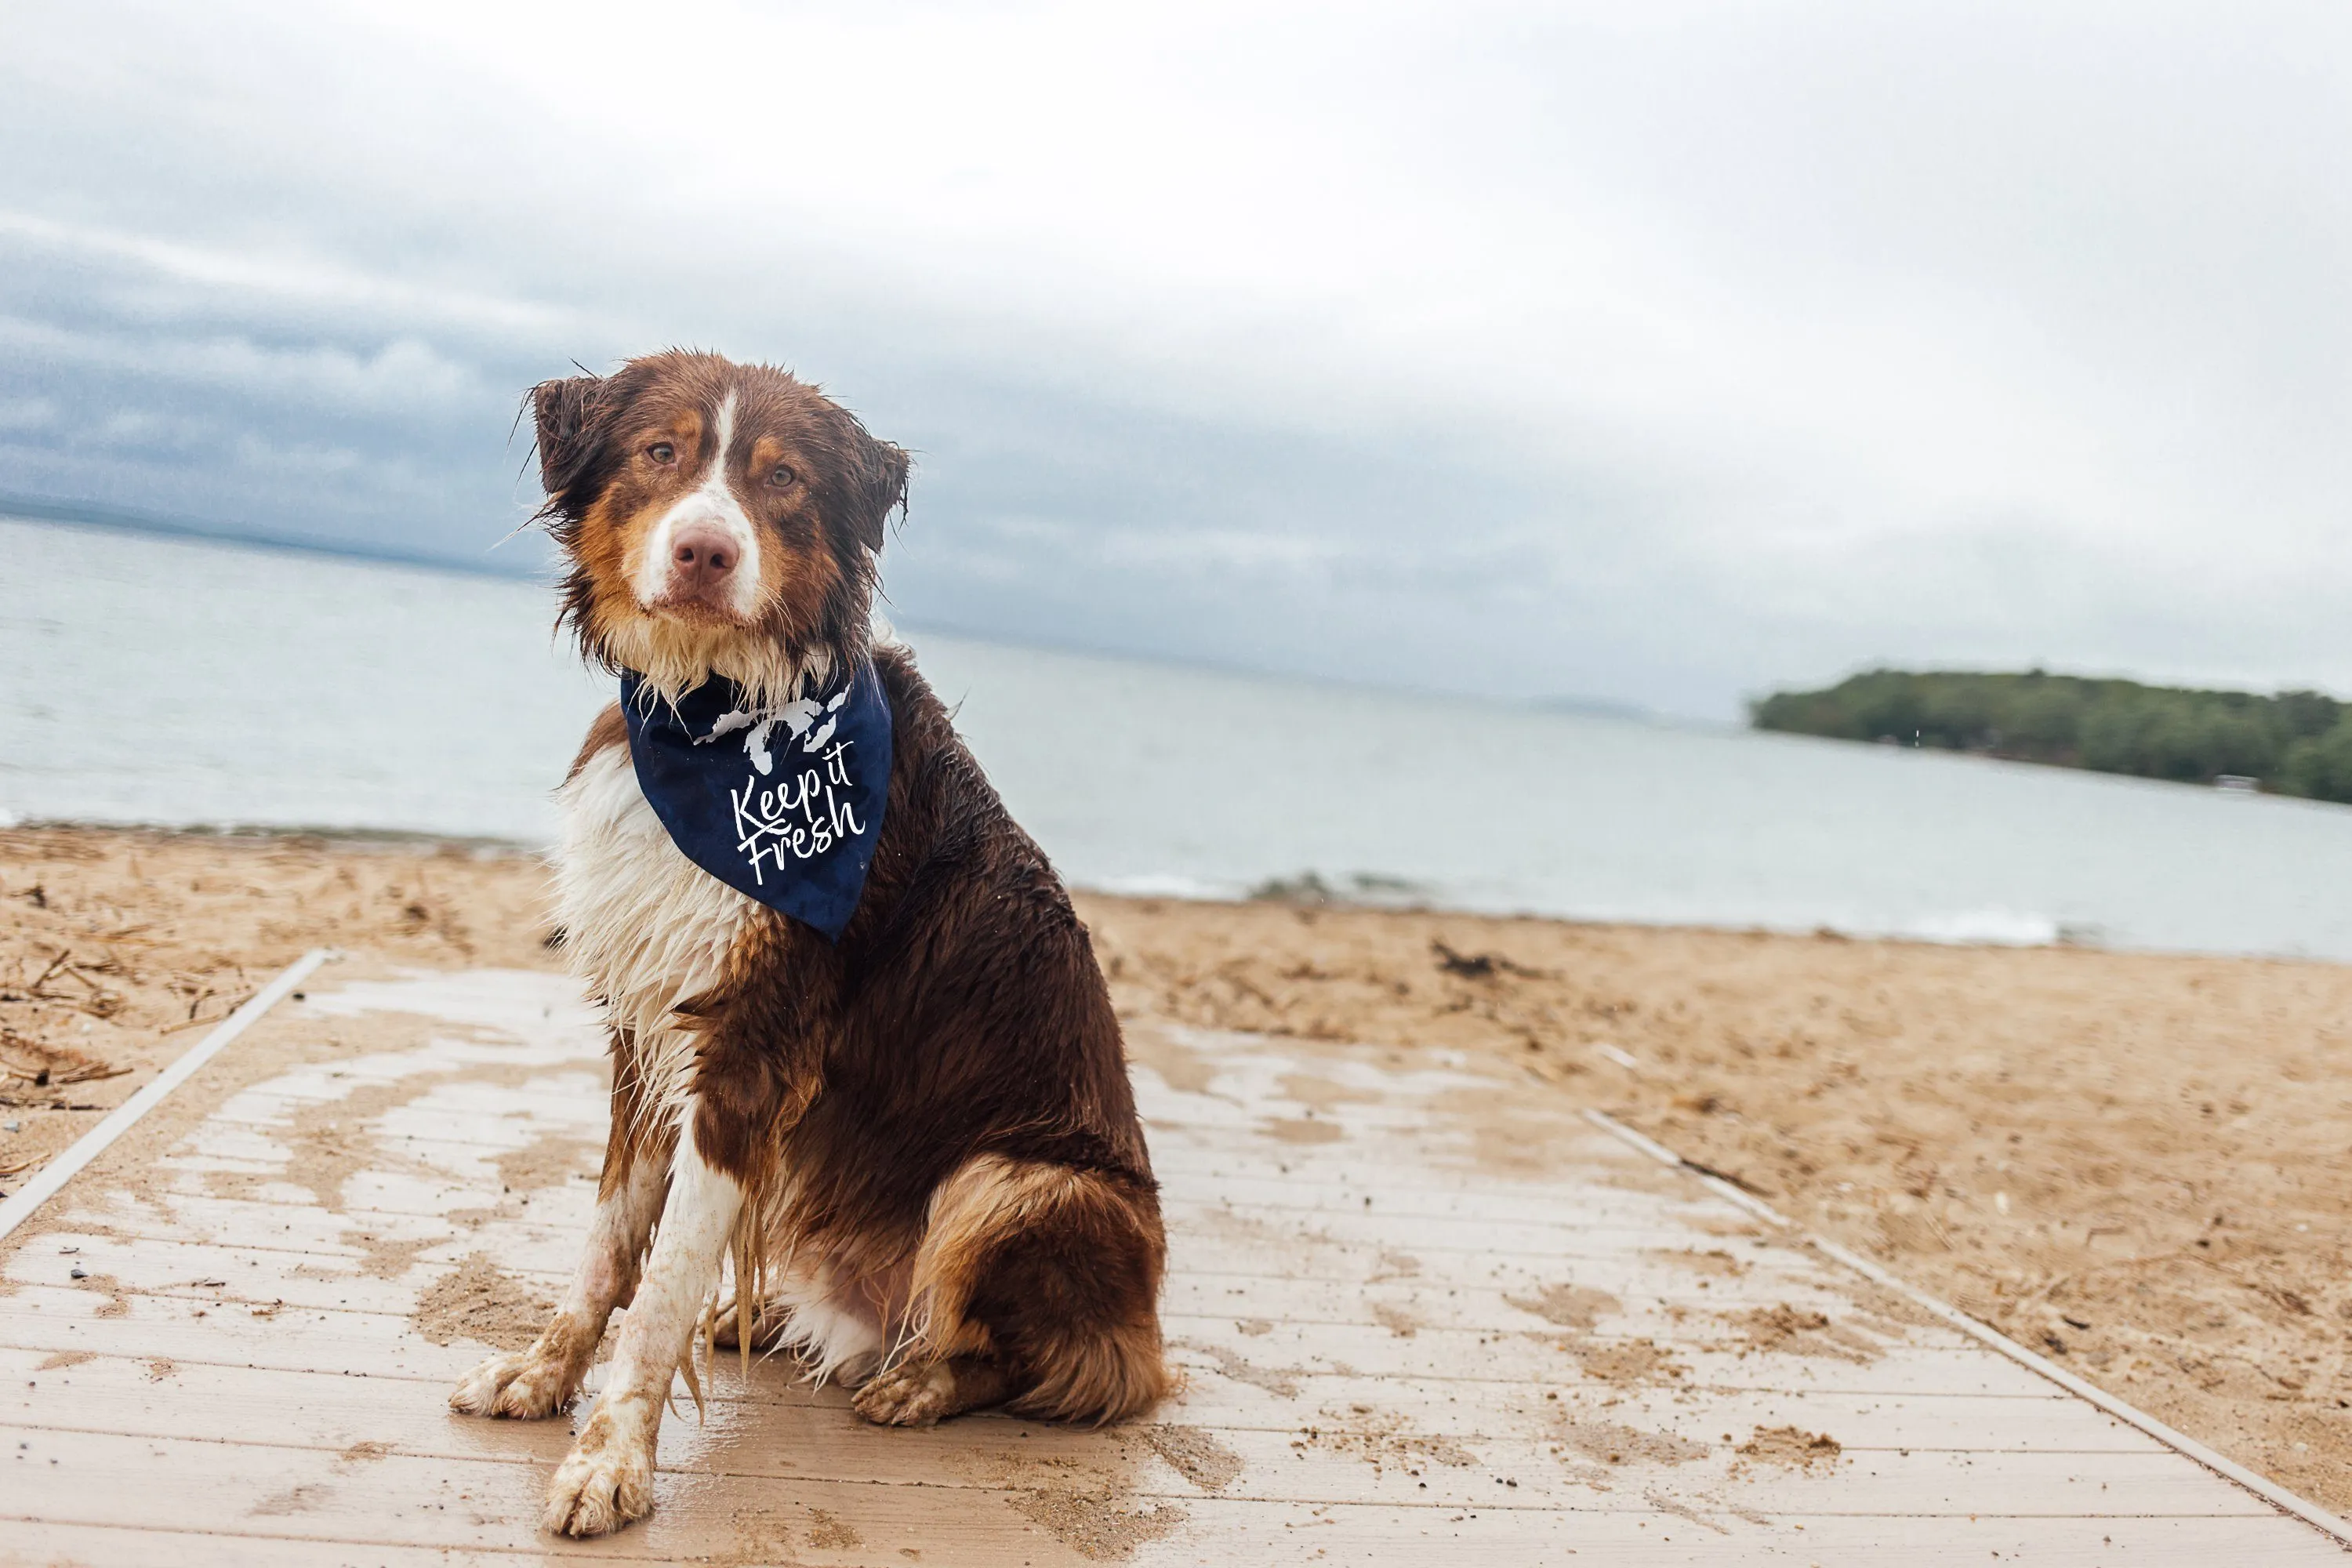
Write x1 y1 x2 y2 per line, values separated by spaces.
621 663 889 940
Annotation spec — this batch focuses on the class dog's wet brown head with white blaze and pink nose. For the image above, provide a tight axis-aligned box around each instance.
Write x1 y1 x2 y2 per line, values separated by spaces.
532 350 906 703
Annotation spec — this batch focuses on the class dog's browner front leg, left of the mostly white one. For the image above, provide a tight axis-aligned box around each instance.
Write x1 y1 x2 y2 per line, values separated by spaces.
449 1067 668 1420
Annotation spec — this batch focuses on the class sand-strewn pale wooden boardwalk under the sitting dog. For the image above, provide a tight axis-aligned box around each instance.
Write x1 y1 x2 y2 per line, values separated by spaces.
0 968 2340 1568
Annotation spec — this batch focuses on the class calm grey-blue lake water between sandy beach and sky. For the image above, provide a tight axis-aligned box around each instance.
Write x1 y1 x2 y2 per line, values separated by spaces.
0 520 2352 959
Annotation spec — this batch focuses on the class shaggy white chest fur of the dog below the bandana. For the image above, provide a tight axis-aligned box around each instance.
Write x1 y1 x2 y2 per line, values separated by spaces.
555 746 753 1067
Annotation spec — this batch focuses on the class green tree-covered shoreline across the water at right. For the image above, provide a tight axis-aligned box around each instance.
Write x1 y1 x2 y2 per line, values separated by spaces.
1748 670 2352 801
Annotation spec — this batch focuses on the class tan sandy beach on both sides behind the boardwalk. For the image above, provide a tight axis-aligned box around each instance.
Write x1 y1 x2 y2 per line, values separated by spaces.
0 829 2352 1509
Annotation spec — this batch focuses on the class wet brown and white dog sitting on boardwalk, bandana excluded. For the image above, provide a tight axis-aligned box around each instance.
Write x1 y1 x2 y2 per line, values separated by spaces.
449 353 1169 1535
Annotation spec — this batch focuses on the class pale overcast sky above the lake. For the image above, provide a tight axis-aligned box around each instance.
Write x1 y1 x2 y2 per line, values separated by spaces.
0 0 2352 717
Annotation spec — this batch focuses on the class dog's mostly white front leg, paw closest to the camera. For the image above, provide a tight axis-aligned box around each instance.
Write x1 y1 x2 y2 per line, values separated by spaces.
546 1100 743 1535
